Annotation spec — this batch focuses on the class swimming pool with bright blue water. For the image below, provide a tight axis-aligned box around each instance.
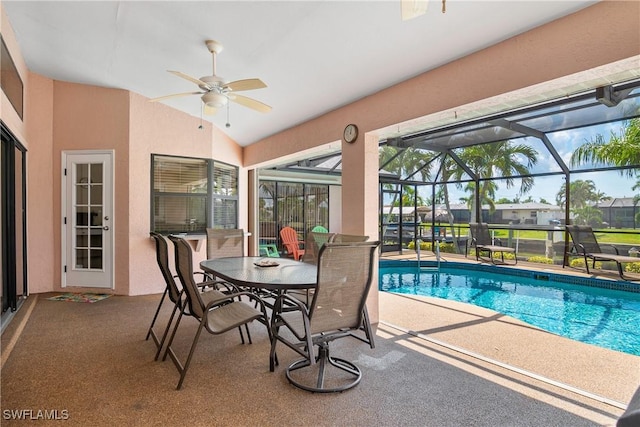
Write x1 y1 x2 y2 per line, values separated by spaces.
379 261 640 356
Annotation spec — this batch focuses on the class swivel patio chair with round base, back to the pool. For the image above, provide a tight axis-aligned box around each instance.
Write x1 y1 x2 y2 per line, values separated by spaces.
270 242 380 393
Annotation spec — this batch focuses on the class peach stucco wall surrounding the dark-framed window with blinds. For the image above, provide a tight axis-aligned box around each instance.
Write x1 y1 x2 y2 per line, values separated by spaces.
128 94 246 295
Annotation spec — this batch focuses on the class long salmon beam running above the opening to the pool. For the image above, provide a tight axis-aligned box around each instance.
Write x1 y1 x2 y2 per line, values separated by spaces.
244 1 640 167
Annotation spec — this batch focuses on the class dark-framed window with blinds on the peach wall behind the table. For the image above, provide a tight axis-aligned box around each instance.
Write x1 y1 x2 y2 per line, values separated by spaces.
151 154 238 234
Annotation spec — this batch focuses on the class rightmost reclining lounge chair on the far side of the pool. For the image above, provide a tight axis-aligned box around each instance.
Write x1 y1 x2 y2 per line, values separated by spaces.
562 225 640 279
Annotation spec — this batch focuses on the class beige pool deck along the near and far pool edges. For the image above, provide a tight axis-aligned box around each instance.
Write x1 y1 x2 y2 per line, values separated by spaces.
379 251 640 412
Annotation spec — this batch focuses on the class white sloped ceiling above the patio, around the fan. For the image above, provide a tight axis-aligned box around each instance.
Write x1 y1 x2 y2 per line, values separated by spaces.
2 0 595 146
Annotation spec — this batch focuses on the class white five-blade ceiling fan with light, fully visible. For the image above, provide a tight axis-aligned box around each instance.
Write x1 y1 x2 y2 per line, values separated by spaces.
150 40 271 114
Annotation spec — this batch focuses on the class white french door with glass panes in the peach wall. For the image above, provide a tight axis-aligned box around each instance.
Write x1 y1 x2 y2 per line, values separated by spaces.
62 151 114 289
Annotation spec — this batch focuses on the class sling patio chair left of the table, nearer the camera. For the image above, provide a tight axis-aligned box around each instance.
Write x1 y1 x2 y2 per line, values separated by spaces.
165 236 271 390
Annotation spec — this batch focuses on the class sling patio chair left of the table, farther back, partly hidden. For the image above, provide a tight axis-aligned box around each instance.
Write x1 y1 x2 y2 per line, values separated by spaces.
145 232 239 360
